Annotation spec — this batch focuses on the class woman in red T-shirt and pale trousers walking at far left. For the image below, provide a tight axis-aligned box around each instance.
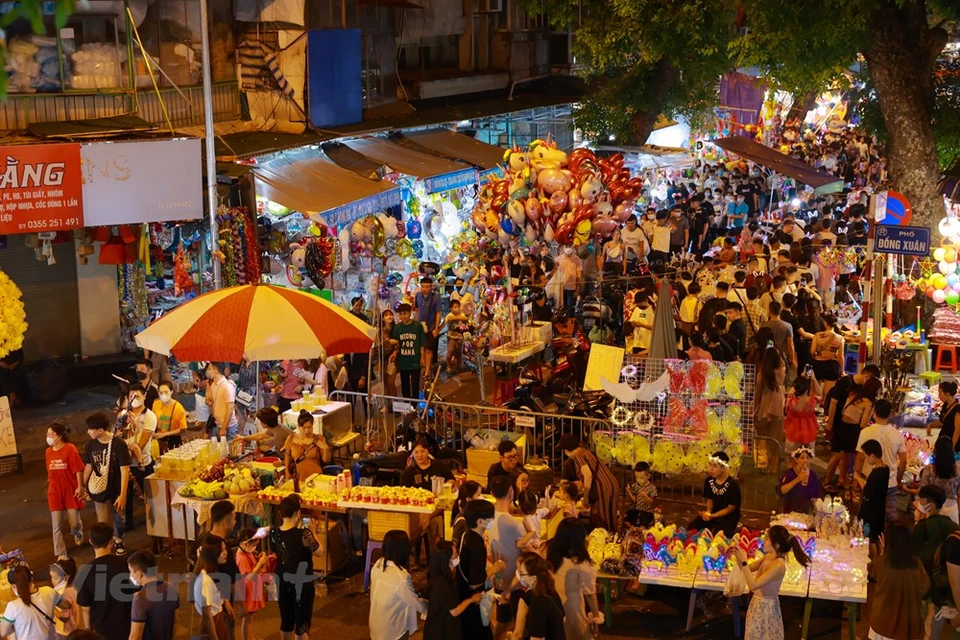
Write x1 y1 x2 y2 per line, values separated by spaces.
47 422 85 559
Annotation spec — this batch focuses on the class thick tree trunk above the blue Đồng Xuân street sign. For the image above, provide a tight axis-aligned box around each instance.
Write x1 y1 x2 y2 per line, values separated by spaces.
863 0 946 228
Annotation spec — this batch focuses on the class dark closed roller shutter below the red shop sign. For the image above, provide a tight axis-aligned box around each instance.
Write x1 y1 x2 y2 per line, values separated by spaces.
0 235 80 362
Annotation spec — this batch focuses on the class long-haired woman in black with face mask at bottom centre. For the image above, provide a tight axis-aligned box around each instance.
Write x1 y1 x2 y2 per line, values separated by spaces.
510 553 567 640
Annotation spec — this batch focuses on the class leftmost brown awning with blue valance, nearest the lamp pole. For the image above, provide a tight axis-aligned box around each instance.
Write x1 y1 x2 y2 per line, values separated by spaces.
254 149 400 227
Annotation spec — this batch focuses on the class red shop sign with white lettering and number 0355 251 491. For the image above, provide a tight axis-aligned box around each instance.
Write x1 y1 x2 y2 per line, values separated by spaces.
0 143 84 234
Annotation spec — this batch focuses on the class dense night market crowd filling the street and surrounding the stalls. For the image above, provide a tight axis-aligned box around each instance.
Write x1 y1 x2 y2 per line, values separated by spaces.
7 121 960 640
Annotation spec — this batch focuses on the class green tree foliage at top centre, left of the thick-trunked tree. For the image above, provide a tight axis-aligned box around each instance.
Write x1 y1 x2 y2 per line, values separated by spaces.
527 0 736 144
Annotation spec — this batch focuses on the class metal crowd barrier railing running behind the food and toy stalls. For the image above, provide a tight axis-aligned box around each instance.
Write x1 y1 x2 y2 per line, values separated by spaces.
330 391 783 513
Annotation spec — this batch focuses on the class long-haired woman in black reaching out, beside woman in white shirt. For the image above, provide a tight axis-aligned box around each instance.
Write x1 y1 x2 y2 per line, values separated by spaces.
423 540 483 640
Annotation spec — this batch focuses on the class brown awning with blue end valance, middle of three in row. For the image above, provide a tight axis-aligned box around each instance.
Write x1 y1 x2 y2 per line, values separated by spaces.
346 138 477 193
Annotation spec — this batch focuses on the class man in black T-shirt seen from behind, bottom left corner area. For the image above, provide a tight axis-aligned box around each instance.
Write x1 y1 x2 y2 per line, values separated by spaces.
74 522 137 640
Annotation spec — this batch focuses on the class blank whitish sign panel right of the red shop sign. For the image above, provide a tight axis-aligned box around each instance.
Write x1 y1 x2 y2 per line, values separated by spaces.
82 138 203 227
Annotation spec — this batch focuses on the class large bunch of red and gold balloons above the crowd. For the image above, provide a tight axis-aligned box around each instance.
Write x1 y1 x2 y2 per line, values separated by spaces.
471 140 643 248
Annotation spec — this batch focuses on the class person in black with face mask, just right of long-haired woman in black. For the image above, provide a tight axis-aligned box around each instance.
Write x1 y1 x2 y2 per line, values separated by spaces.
456 500 505 640
